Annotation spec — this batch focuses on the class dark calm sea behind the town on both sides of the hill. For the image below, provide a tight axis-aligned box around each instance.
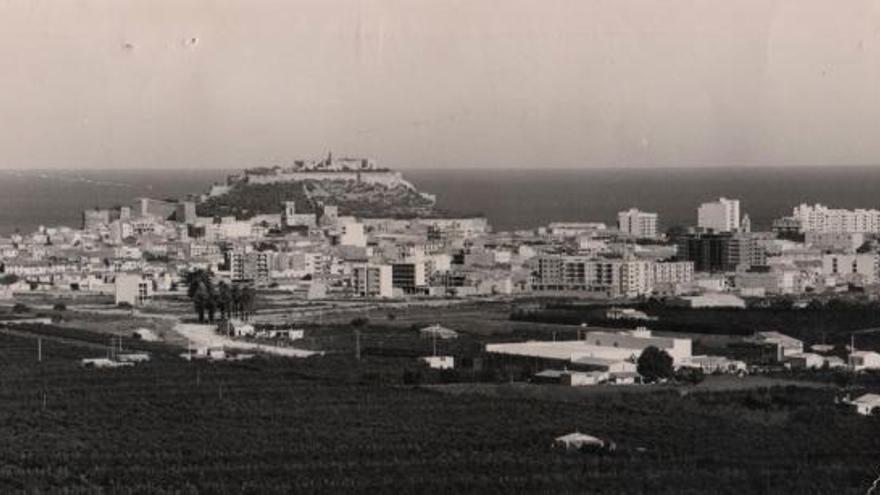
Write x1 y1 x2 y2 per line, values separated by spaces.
0 166 880 235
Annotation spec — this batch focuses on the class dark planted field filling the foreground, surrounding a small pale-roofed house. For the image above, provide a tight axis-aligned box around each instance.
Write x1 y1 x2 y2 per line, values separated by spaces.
0 327 880 494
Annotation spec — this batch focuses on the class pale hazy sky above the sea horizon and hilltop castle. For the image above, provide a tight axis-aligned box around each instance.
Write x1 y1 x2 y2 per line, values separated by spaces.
0 0 880 168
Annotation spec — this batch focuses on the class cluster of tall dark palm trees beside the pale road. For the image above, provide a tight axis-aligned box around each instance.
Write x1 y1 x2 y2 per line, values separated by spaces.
184 269 257 323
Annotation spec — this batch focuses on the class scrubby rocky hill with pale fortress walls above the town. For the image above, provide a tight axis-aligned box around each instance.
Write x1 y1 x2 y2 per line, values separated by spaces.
196 180 435 219
